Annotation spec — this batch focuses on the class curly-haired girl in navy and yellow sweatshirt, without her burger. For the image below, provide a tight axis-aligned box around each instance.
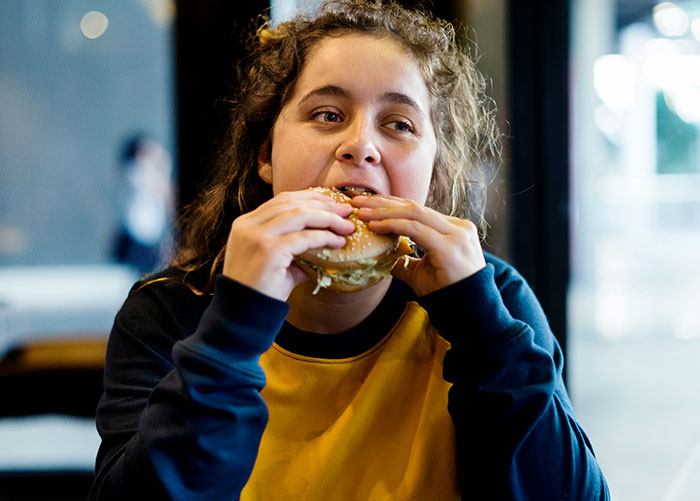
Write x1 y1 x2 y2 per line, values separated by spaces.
91 0 608 500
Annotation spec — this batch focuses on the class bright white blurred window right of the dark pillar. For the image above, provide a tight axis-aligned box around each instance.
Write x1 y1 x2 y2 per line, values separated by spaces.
569 0 700 500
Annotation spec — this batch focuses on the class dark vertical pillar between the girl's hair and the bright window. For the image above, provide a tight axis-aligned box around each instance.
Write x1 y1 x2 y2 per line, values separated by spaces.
508 0 570 360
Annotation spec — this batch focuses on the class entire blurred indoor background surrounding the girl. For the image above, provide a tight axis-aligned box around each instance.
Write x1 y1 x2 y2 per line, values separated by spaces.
0 0 700 501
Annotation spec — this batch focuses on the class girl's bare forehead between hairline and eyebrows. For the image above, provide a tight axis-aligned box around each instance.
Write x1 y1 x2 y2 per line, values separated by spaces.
292 33 429 107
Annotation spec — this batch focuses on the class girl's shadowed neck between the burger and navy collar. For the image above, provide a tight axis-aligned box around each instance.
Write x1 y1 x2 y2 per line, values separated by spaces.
287 280 391 334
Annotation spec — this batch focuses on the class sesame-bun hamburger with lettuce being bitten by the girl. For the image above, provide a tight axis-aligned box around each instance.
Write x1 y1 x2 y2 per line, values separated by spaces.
295 187 413 294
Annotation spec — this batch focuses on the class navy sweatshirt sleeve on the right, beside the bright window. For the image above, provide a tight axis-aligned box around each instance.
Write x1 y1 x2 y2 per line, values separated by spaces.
420 262 610 501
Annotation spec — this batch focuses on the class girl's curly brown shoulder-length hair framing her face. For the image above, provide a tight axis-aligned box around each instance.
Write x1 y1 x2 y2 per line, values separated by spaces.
173 0 500 286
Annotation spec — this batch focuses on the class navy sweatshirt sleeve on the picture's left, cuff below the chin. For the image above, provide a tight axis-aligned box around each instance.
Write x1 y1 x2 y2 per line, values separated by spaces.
90 276 288 500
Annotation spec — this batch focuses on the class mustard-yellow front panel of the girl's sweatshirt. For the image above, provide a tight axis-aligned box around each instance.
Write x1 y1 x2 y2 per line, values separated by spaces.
241 302 460 501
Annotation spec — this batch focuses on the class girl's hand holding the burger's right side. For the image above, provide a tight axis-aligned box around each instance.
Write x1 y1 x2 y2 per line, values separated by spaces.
352 195 486 296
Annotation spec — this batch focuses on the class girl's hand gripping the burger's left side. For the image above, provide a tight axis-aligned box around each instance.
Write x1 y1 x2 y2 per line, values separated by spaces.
223 190 355 301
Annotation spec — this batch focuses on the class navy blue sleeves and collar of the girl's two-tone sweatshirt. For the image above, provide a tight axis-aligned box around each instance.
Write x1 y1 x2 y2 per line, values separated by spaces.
91 254 609 500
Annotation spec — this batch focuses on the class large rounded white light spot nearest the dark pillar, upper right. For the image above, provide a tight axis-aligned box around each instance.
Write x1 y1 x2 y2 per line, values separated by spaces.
593 54 635 112
